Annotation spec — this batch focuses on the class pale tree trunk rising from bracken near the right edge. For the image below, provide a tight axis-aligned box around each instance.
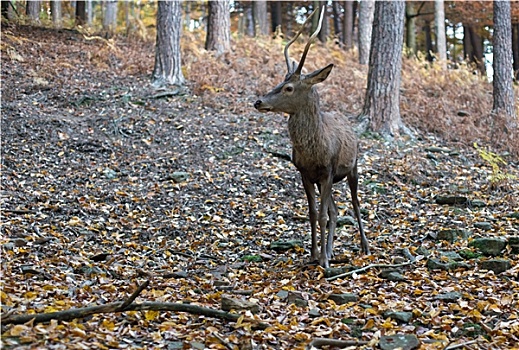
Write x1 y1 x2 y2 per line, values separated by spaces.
492 0 517 128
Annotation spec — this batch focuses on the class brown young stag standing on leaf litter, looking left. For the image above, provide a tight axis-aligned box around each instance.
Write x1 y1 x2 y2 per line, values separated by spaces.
254 7 370 268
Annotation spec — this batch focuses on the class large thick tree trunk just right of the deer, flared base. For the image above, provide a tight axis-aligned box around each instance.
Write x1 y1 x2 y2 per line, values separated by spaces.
360 1 405 137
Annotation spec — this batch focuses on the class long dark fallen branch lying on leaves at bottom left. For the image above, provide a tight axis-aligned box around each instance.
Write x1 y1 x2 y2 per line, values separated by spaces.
4 302 270 329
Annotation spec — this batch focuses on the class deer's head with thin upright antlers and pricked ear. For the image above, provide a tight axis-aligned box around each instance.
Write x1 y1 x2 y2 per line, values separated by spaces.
254 8 333 114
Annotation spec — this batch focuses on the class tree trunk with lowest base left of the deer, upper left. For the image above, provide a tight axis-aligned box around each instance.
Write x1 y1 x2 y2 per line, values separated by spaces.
152 1 185 87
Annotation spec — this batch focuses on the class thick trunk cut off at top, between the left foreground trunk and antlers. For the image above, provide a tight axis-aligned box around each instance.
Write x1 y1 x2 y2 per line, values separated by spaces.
205 0 231 54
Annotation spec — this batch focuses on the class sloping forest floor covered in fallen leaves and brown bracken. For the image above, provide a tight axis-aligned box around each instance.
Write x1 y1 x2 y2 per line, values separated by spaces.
0 26 519 349
